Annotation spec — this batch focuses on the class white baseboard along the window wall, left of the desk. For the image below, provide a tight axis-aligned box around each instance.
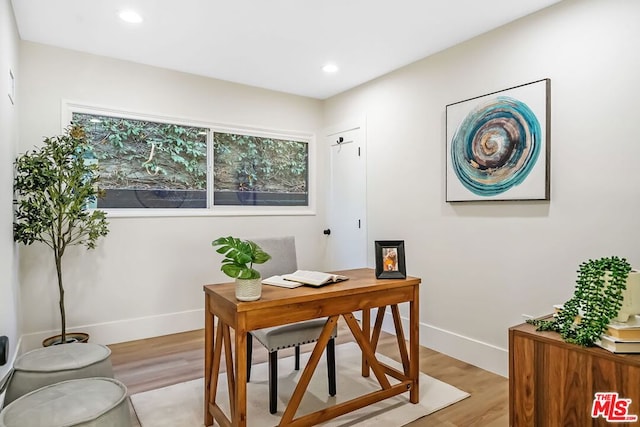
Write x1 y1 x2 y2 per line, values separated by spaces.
21 309 204 351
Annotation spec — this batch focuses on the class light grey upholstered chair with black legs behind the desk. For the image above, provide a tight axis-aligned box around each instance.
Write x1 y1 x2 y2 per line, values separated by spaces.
247 236 338 414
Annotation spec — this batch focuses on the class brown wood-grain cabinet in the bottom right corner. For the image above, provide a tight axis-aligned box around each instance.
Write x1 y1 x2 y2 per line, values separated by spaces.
509 323 640 427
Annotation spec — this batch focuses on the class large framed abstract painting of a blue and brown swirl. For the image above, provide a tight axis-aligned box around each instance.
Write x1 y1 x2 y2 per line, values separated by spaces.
445 79 551 202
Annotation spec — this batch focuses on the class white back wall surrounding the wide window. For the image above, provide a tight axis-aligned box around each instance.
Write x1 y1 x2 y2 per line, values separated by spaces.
20 42 325 347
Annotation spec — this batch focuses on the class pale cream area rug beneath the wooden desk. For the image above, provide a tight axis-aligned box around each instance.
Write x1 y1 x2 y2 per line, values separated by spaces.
131 343 469 427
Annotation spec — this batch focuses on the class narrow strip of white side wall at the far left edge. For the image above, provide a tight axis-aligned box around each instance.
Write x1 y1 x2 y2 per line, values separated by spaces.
0 0 21 392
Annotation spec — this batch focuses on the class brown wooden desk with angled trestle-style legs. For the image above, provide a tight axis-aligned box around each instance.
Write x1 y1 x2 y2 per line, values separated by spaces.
204 268 420 426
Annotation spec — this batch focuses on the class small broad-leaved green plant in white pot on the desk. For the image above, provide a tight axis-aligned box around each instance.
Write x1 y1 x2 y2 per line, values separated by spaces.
211 236 271 301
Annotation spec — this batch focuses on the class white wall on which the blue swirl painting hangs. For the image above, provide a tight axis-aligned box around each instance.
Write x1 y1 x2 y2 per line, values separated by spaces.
324 0 640 375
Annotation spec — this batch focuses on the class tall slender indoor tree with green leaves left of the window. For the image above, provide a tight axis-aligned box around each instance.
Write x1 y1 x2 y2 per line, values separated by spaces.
13 125 109 344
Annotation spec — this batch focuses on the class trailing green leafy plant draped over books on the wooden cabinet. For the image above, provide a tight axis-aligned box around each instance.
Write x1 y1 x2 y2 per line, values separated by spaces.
528 256 631 347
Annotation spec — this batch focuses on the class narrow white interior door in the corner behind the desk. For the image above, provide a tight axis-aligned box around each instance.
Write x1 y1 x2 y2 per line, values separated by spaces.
326 127 367 270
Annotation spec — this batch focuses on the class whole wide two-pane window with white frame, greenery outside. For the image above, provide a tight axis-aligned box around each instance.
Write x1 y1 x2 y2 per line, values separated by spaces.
70 105 312 213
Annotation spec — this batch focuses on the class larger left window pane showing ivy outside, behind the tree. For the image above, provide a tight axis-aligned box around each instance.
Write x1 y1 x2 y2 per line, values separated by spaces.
72 113 207 208
